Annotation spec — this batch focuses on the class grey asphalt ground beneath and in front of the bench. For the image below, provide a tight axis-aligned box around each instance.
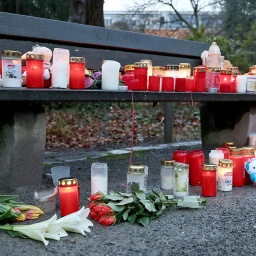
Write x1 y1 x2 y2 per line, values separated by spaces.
0 142 256 256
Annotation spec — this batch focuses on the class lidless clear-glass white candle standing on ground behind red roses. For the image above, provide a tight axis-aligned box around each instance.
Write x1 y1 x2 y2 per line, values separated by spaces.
91 163 108 194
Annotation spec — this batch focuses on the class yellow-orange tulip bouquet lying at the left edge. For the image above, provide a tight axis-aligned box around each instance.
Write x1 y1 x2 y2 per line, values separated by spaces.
0 195 43 222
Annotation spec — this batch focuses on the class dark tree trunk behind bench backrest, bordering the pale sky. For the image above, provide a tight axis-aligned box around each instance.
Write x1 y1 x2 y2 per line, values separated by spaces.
70 0 104 27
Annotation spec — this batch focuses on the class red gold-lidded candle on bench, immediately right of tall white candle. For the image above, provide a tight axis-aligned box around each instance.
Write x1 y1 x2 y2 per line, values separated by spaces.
69 57 85 89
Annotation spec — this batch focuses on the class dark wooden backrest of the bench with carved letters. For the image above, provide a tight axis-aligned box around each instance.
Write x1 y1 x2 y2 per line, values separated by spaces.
0 12 209 69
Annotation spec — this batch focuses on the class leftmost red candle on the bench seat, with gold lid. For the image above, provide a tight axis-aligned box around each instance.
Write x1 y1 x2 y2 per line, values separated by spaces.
26 53 44 88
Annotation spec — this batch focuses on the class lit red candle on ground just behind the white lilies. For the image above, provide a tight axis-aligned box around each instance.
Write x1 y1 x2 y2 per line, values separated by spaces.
59 178 79 216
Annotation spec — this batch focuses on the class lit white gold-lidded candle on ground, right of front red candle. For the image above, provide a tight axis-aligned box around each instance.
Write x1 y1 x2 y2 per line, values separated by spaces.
217 159 233 191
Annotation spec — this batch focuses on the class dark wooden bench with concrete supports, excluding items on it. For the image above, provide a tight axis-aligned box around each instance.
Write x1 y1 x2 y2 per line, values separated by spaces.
0 12 255 189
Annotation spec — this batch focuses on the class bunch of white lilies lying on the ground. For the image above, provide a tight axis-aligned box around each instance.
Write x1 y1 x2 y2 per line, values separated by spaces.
0 207 93 245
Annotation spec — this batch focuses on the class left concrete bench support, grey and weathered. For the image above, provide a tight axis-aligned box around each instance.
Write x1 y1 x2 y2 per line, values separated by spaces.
0 102 46 190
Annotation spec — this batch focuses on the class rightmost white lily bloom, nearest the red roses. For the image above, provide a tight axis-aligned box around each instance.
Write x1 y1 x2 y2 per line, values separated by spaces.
53 206 93 235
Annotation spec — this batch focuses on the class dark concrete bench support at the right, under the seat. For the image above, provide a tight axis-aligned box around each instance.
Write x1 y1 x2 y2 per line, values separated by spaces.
200 102 256 149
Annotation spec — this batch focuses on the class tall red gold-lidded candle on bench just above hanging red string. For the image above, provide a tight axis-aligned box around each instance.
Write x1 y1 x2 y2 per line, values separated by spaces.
134 62 148 91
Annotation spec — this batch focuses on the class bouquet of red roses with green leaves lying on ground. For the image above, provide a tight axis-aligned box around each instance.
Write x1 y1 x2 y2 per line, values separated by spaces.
88 184 206 227
